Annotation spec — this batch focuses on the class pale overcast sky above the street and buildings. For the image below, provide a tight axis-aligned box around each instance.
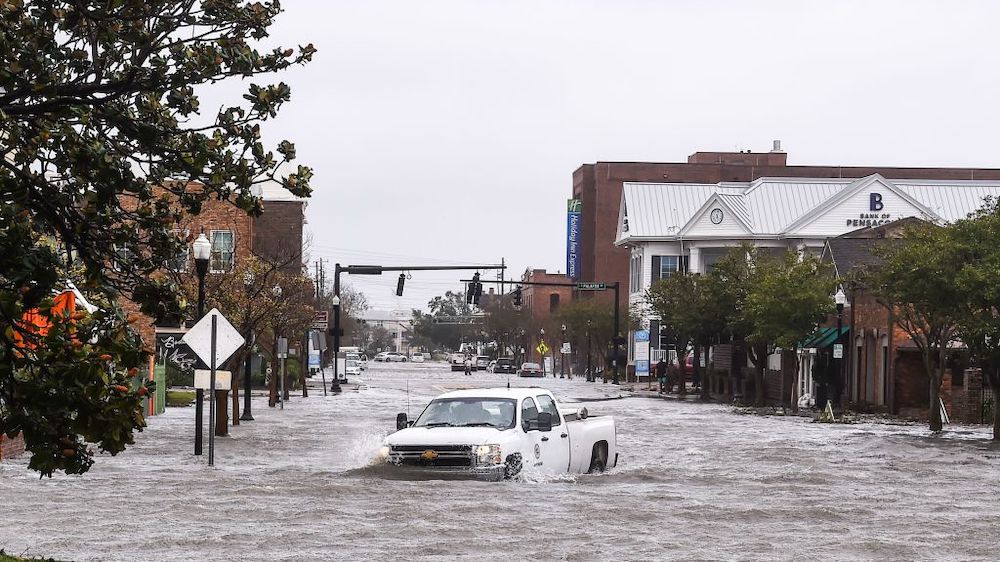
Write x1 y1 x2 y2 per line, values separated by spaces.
234 0 1000 309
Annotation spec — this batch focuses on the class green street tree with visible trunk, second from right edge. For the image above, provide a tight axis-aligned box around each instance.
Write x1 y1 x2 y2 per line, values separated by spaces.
869 223 960 431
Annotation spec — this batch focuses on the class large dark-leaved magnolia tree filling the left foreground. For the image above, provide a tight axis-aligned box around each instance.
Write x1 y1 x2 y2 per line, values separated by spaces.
0 0 315 475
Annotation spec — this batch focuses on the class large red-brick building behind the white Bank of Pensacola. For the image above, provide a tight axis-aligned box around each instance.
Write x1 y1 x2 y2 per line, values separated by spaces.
572 141 1000 307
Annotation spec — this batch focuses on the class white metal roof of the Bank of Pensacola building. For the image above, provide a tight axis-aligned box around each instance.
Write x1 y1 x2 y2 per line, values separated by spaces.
617 174 1000 244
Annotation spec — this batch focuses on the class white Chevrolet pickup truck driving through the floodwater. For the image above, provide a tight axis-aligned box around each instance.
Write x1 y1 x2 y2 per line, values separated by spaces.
379 388 618 480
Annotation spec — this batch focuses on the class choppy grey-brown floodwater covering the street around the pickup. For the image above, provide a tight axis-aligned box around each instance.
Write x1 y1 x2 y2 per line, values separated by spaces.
0 363 1000 561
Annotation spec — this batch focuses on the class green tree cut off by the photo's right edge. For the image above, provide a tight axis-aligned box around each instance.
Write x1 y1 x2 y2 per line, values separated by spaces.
947 199 1000 441
